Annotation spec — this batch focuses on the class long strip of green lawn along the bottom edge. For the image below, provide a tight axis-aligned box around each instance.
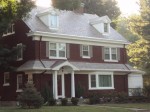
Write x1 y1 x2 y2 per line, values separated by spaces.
0 106 134 112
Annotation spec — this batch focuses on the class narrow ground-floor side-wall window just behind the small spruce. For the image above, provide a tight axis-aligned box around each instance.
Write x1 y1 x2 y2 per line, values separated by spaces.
16 74 23 92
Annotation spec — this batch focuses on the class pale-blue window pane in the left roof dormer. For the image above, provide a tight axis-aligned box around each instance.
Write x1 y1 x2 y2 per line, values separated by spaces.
50 15 58 29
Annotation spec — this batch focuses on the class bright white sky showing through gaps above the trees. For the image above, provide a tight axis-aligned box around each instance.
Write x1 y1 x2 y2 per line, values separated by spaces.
36 0 139 16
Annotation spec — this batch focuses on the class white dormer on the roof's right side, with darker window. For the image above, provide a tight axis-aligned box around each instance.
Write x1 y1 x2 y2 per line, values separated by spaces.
90 16 111 35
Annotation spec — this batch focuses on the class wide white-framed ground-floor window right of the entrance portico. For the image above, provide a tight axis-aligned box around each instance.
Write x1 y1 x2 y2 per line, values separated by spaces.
89 72 114 90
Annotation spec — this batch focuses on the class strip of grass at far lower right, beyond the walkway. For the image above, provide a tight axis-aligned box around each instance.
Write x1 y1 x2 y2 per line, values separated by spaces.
104 103 150 110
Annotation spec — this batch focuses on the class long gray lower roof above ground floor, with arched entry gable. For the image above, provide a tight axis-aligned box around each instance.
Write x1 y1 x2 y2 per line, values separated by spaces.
17 60 143 74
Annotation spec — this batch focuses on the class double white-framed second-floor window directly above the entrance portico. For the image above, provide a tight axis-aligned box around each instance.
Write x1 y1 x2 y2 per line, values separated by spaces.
49 43 66 58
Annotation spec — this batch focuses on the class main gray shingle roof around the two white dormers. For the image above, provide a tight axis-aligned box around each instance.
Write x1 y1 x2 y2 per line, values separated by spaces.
24 7 127 42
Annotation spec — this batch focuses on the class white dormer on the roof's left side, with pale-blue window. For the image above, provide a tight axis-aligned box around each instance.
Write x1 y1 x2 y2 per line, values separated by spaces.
37 8 59 30
